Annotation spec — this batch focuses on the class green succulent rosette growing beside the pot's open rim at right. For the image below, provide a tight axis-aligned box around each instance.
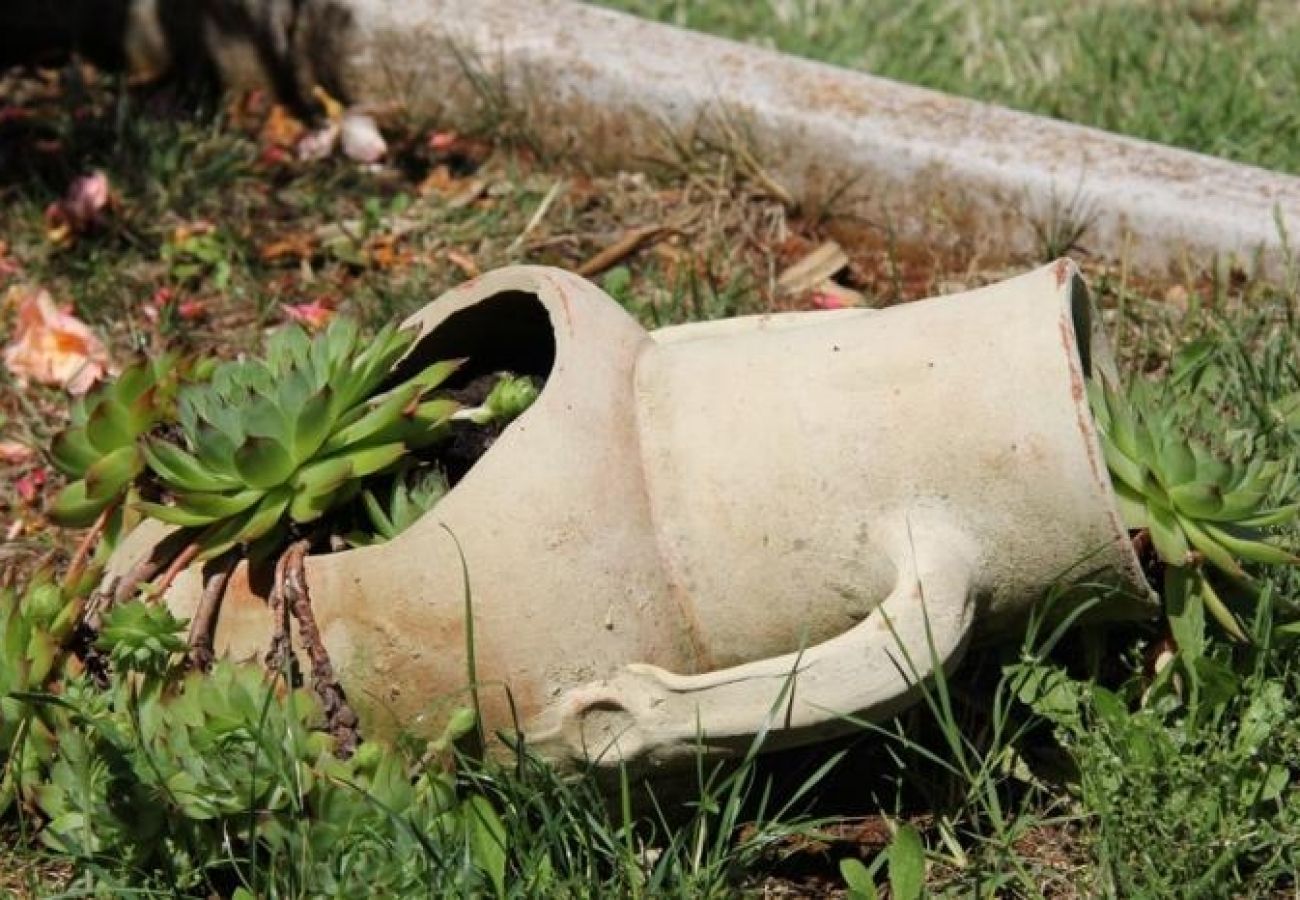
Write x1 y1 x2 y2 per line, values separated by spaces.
1089 381 1300 640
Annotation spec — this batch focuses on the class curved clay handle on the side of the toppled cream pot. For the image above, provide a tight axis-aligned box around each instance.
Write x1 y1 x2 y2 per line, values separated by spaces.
530 511 975 766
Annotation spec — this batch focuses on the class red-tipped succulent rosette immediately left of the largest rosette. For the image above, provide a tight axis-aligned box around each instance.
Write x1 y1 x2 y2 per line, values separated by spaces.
49 354 178 525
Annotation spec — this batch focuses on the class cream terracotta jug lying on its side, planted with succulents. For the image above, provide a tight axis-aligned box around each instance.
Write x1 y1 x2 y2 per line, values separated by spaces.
106 261 1154 766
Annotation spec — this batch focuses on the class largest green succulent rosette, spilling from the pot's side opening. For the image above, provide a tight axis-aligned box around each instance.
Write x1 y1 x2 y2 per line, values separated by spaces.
139 317 459 559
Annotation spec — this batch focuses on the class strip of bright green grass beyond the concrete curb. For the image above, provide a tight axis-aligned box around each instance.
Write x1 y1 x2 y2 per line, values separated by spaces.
599 0 1300 173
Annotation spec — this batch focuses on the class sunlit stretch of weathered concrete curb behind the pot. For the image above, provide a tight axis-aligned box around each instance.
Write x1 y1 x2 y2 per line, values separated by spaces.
350 0 1300 274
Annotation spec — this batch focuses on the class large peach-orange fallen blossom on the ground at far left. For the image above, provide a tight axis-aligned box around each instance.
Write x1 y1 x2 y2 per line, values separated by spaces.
4 286 109 394
